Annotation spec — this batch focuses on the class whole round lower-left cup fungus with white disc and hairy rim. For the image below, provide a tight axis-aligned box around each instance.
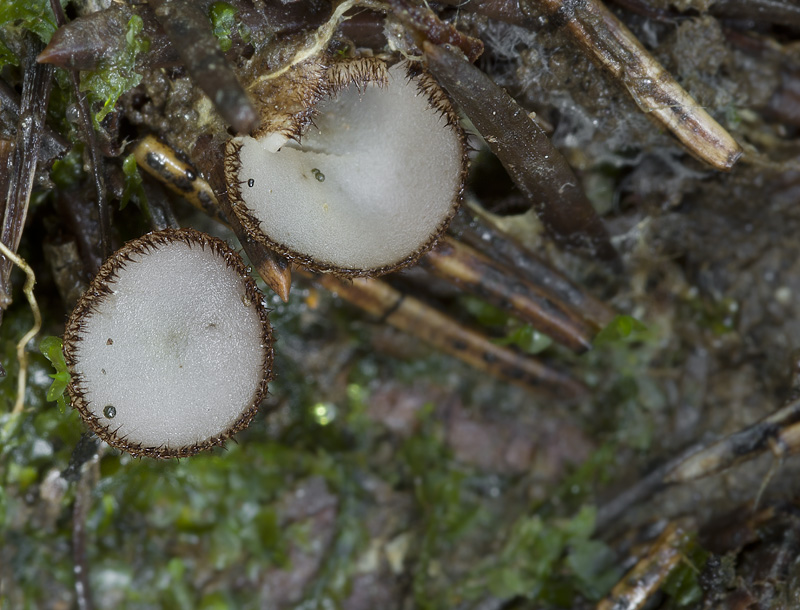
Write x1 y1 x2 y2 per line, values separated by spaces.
64 229 272 457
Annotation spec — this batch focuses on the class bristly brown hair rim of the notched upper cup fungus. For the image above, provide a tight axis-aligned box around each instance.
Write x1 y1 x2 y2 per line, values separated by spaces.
224 57 469 278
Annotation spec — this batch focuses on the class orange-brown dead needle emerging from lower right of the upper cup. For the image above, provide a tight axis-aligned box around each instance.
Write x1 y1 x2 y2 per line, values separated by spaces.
421 238 594 352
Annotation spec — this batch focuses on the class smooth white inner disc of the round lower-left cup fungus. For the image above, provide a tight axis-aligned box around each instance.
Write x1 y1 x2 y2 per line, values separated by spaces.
75 242 268 448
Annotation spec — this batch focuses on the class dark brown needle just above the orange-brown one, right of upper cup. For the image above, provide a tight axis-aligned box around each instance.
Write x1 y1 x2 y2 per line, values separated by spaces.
451 204 616 330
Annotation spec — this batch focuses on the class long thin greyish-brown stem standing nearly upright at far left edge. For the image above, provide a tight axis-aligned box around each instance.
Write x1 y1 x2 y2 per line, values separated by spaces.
0 35 55 310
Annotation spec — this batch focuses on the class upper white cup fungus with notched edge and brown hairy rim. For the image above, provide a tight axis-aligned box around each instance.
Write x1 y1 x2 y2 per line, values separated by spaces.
225 58 467 276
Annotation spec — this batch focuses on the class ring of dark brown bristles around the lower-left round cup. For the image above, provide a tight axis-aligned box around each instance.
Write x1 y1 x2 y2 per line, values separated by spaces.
64 229 273 458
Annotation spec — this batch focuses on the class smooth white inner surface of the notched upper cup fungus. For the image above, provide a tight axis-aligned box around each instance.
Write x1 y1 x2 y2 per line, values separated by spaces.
234 65 462 269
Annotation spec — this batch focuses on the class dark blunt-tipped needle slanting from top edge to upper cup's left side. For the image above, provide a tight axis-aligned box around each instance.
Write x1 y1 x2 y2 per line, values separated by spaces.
145 0 258 133
